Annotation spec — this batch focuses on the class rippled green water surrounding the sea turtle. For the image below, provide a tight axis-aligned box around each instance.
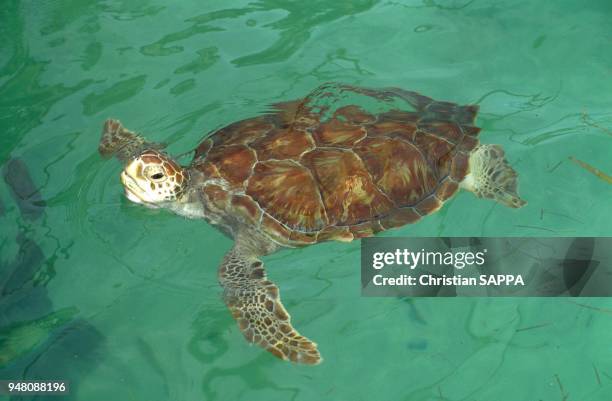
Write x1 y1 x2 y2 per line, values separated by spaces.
0 0 612 401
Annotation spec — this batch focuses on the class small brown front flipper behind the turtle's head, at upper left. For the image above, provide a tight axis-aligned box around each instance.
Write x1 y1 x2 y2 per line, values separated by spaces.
98 119 164 161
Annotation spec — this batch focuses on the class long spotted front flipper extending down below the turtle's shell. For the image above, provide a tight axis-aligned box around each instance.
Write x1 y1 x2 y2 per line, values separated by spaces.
219 244 321 365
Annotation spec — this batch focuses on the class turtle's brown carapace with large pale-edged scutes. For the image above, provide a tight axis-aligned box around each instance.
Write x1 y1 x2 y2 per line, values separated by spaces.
193 84 480 246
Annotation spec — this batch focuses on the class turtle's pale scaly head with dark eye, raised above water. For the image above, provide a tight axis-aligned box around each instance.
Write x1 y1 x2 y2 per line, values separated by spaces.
121 149 188 208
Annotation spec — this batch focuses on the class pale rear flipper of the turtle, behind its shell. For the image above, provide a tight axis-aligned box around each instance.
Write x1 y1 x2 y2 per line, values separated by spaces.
461 145 527 208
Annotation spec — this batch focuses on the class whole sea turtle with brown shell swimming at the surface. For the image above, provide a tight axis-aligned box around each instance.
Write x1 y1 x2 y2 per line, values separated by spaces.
99 84 525 364
